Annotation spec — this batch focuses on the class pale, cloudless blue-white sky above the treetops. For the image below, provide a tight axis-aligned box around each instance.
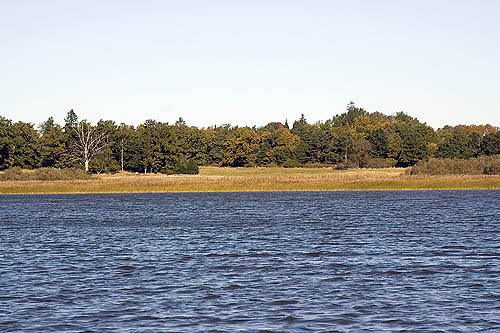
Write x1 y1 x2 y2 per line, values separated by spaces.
0 0 500 129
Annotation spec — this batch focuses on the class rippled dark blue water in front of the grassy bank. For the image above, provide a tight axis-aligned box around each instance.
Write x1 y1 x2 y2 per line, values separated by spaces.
0 191 500 332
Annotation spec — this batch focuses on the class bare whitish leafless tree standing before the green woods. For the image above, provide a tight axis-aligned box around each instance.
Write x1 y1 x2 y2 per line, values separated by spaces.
71 120 109 172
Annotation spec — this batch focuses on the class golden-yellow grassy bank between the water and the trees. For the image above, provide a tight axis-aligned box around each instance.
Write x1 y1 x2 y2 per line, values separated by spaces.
0 167 500 194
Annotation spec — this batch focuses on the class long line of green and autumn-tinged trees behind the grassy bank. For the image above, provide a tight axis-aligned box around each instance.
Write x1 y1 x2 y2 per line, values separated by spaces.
0 102 500 173
